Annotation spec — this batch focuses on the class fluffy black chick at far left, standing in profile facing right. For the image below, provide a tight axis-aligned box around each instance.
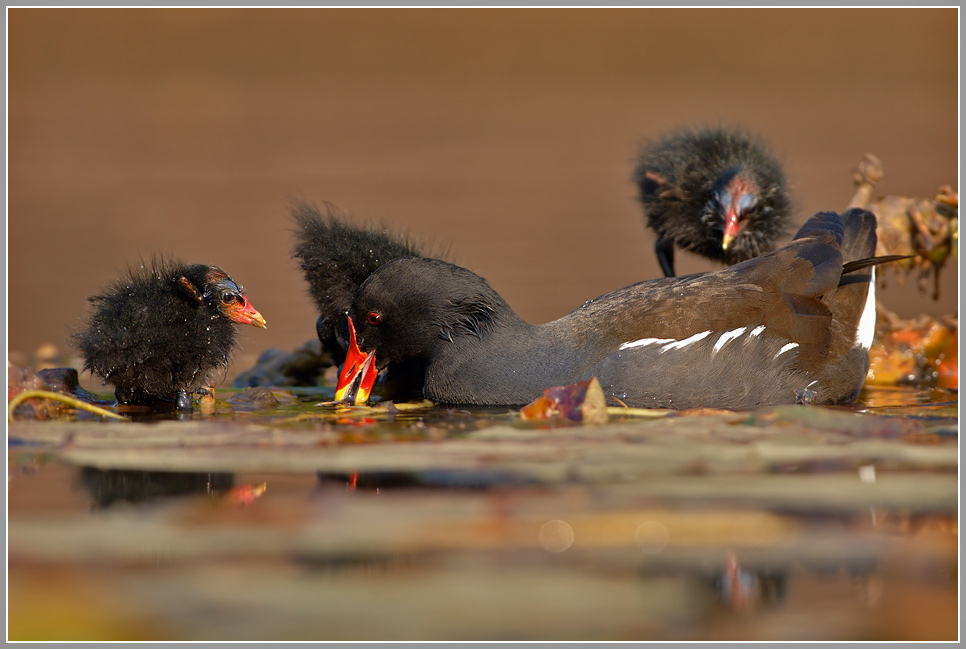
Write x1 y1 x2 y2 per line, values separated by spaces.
73 258 265 410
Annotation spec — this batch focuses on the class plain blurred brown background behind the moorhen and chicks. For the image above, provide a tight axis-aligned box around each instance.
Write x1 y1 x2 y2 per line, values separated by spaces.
7 9 959 374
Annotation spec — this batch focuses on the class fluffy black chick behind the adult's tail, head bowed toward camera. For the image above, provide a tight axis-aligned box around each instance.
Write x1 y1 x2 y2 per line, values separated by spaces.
634 128 791 277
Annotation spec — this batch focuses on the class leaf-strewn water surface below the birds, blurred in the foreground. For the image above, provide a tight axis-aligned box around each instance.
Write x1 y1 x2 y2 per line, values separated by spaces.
8 389 959 640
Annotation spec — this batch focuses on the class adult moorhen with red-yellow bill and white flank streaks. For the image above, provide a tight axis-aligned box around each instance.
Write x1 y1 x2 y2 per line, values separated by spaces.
337 209 900 410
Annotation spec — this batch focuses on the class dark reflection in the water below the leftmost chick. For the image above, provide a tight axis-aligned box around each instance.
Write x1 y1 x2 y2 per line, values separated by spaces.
78 467 235 509
